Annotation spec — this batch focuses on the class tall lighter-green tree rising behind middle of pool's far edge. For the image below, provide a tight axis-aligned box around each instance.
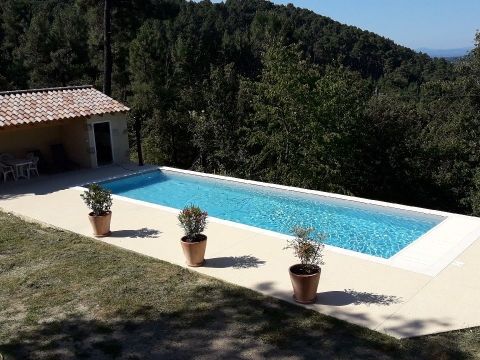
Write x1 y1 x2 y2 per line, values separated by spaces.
241 44 320 185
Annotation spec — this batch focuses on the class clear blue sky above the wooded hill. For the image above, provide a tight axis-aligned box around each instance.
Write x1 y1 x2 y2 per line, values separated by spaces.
211 0 480 49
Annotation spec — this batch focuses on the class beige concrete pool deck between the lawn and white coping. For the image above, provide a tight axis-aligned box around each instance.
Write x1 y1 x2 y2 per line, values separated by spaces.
0 166 480 338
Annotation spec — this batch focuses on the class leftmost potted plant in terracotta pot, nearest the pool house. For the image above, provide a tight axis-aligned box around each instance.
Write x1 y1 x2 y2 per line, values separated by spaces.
80 184 112 237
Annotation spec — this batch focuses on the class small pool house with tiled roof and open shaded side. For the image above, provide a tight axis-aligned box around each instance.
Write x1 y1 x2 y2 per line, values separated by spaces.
0 86 129 168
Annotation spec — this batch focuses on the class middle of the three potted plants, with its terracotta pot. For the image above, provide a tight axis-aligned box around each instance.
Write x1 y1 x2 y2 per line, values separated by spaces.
178 205 208 267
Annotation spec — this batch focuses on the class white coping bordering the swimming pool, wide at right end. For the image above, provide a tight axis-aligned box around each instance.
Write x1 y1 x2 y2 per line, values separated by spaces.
73 166 480 277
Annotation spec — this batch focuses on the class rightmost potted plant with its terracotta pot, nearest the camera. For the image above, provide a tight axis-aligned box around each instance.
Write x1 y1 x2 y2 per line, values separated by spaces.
286 227 326 304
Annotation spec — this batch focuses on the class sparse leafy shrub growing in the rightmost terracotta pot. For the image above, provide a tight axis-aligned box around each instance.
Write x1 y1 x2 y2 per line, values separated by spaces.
286 226 326 274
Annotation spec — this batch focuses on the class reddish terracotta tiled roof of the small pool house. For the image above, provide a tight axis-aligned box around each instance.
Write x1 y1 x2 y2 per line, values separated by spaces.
0 86 129 129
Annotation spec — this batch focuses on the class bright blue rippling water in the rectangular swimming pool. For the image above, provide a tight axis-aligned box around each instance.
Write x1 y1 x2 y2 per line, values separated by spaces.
102 170 443 258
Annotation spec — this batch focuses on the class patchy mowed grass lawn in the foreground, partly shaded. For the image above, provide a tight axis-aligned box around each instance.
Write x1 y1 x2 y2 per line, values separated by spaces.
0 212 480 359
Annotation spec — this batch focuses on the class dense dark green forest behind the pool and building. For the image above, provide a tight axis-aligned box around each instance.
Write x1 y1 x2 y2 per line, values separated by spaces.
0 0 480 215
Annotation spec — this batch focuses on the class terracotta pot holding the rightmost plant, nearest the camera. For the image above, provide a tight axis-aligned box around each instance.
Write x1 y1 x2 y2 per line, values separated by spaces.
289 264 322 304
